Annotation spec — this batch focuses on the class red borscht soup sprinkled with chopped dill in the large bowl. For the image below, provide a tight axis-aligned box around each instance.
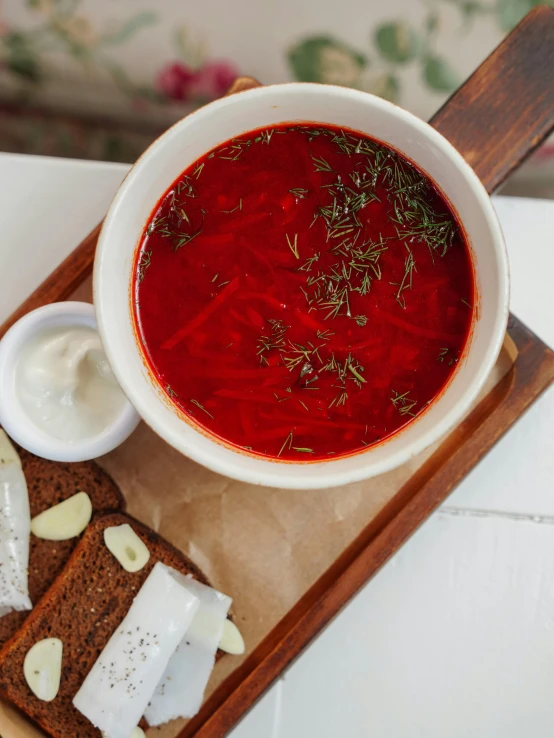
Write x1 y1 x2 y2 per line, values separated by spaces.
133 123 475 461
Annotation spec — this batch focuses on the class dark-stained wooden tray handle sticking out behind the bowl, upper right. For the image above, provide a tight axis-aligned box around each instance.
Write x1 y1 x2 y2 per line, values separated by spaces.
429 6 554 192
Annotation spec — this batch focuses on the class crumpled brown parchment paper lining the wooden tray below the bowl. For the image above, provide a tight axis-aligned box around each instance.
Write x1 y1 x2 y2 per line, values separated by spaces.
0 278 515 738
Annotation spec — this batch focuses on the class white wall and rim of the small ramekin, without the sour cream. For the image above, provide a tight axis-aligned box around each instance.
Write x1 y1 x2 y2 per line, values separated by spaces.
0 302 140 461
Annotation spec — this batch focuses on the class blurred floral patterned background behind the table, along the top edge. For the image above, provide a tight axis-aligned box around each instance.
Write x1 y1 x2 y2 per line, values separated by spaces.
0 0 554 193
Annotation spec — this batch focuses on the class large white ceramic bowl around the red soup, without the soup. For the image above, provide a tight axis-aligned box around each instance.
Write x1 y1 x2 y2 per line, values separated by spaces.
94 84 508 488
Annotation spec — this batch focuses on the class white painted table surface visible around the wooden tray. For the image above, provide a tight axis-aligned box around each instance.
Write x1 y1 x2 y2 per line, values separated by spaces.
0 154 554 738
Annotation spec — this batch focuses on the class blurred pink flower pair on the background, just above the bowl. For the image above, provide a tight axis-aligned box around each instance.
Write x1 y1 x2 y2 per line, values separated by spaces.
157 61 238 102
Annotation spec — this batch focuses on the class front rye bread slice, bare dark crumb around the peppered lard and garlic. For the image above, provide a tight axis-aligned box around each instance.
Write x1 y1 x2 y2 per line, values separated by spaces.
0 513 208 738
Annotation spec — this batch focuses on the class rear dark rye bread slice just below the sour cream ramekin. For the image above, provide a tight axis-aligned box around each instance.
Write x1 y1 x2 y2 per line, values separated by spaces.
0 447 125 648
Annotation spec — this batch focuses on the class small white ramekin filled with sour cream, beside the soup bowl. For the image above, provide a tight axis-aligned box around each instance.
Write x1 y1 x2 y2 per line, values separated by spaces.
0 302 139 461
